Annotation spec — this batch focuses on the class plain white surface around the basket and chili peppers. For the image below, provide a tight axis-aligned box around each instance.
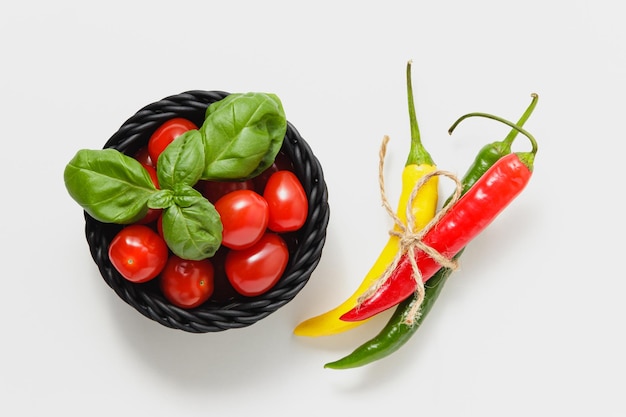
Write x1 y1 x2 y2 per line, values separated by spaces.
0 0 626 417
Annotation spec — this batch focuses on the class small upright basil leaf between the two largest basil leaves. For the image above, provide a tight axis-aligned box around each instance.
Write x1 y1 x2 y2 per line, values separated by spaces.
157 129 205 189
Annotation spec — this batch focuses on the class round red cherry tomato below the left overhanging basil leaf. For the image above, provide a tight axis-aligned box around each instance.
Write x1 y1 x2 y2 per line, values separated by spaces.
109 224 168 282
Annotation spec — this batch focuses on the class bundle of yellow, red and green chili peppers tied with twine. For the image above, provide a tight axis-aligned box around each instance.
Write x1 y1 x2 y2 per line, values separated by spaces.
294 61 538 369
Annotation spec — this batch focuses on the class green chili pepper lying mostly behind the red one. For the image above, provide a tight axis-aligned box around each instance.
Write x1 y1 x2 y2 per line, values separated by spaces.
324 93 538 369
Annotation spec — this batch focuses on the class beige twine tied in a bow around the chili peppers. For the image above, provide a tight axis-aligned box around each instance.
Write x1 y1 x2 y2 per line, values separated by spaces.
358 135 463 326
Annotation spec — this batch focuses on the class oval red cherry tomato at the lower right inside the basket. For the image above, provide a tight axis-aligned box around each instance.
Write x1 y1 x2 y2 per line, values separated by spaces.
224 232 289 297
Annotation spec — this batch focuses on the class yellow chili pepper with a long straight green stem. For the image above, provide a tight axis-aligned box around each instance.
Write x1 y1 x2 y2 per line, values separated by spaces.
294 61 439 337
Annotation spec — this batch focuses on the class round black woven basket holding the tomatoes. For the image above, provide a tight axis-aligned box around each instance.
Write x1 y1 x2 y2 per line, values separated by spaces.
85 90 329 333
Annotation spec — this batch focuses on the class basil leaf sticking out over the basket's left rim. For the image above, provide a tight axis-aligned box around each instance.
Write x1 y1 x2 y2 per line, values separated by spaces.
63 149 156 224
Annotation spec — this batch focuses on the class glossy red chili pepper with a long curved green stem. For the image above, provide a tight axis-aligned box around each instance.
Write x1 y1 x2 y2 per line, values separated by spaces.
341 113 536 321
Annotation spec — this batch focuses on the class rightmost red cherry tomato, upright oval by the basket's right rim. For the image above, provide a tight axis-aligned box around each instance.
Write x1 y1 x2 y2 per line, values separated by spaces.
263 170 309 232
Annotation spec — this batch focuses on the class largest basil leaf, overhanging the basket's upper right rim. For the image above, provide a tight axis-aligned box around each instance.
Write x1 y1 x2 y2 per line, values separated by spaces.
200 93 287 180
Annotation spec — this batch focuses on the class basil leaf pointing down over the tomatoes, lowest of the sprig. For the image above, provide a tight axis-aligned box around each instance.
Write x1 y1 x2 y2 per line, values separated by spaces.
163 196 222 260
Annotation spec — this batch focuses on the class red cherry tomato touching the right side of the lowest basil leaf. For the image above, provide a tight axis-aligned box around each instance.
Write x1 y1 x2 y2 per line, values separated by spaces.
215 190 269 249
